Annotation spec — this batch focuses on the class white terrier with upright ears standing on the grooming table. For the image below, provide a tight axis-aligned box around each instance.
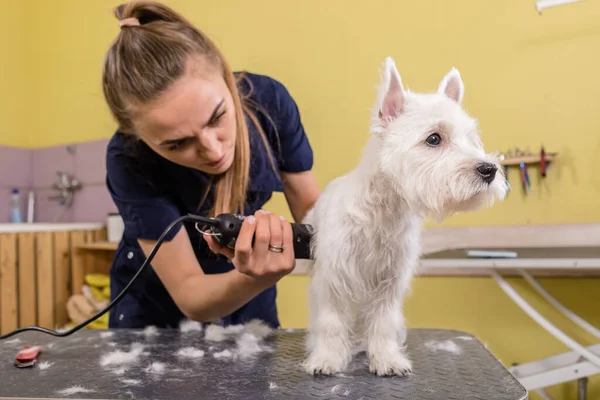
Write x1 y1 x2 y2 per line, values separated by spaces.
304 58 506 375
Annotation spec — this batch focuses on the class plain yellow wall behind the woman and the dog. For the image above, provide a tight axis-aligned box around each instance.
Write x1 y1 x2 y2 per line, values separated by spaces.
0 0 600 398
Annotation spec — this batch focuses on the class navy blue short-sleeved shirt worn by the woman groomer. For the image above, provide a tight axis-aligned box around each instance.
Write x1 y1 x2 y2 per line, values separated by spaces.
106 73 313 328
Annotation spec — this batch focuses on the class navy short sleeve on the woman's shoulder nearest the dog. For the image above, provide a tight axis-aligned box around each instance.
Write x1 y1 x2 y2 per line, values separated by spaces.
271 79 313 172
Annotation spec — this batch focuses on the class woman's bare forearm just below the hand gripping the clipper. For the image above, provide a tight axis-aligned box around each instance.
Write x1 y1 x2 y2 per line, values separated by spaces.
179 269 269 322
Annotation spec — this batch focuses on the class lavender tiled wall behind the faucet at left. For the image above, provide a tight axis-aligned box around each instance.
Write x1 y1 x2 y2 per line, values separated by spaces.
0 139 116 223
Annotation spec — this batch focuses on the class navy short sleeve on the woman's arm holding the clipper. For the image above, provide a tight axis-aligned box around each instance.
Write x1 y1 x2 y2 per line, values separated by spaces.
106 138 182 241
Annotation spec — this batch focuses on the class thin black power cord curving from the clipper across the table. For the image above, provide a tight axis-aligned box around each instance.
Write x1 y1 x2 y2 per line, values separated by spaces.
0 214 217 340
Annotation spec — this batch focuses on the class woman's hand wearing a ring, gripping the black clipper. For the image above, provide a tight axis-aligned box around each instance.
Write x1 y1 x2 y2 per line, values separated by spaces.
204 210 295 286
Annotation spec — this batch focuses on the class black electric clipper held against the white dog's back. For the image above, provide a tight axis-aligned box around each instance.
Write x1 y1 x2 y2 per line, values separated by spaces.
207 214 313 260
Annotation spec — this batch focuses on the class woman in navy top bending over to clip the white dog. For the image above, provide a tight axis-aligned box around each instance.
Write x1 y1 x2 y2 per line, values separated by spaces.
103 2 319 328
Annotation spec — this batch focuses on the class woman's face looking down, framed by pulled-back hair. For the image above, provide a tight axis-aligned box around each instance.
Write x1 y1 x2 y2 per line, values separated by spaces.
134 63 236 174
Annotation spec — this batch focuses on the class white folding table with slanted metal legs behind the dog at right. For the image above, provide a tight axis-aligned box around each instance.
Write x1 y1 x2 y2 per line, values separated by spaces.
419 246 600 400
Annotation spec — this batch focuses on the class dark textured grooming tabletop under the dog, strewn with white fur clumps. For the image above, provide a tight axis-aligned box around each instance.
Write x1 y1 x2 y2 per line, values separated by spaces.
0 329 528 400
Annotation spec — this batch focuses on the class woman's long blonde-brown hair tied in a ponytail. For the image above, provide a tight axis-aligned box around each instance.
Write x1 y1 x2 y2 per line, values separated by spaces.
102 1 277 216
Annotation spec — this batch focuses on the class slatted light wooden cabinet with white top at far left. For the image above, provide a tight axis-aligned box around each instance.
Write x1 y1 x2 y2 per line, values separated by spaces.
0 224 110 334
